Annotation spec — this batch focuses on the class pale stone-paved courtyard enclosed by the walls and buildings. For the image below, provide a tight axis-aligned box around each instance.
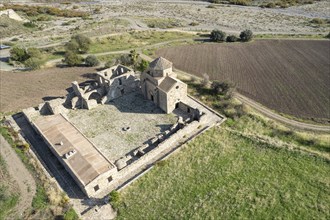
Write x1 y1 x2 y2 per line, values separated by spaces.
68 92 177 162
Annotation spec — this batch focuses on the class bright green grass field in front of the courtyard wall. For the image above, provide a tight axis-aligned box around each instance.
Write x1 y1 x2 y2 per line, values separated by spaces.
118 125 330 219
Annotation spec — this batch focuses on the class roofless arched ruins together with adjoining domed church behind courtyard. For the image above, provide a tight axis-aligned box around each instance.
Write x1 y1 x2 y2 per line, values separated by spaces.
69 57 187 113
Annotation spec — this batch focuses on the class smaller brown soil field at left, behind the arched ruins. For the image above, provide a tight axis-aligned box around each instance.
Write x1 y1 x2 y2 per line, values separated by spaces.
0 67 96 112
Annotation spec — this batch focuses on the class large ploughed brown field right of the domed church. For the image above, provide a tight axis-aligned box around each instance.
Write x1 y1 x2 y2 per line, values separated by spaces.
156 40 330 123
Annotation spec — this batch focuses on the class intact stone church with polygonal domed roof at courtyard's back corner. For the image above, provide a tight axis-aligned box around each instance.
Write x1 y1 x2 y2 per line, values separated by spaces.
140 57 187 113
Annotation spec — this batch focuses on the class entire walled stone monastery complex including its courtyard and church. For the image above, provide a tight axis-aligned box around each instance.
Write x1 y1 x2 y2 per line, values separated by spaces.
23 57 224 198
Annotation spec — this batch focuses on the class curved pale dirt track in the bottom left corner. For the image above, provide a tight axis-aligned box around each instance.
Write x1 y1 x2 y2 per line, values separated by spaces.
0 135 36 218
